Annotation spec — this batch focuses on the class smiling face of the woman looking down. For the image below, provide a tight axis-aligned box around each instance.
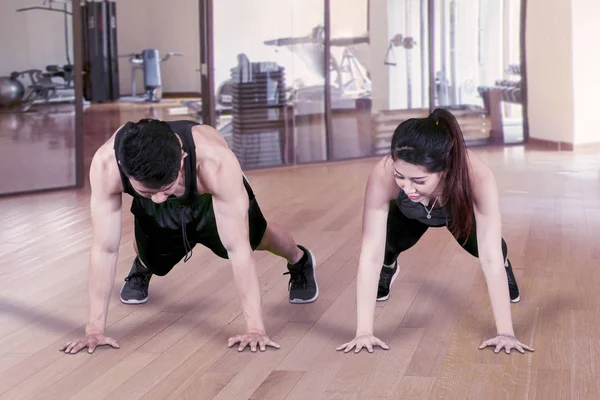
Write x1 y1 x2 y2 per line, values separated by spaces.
394 160 444 202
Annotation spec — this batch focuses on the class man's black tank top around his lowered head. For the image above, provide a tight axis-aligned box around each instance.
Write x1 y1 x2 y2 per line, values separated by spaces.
114 121 212 229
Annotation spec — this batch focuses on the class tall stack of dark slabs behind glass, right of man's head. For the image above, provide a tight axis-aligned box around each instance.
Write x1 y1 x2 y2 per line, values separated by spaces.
231 55 293 168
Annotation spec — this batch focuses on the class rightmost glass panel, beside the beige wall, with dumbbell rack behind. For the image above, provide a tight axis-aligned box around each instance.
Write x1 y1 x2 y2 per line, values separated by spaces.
433 0 523 144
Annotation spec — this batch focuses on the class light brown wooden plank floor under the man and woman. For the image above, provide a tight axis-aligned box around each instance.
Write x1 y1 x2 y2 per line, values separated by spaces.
0 101 600 400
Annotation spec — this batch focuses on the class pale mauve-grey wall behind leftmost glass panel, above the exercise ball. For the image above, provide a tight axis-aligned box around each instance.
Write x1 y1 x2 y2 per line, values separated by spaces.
0 0 73 76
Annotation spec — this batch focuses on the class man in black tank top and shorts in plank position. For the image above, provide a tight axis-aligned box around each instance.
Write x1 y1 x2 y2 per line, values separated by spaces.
61 119 319 353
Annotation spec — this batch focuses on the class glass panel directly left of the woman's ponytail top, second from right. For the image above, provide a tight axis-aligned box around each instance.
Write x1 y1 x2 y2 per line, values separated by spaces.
330 0 429 159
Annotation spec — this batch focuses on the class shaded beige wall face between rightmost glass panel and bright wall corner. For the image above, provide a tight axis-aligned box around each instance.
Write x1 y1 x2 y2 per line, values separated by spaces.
526 0 576 143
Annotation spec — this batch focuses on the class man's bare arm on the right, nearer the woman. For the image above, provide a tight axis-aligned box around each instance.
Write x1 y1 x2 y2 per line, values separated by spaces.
211 150 270 350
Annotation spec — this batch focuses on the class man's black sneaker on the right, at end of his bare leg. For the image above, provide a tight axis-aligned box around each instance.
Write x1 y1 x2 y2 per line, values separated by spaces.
284 246 319 304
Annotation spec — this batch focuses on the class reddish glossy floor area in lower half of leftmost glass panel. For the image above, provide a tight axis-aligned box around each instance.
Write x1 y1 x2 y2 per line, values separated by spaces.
0 105 75 194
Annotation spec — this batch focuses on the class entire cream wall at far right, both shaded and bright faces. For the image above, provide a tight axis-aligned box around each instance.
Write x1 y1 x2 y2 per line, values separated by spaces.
526 0 600 147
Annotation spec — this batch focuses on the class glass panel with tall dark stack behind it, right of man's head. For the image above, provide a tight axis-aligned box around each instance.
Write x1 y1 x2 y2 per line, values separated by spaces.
213 0 327 169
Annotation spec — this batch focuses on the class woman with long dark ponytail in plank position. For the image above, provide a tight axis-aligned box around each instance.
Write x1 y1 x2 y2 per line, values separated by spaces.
337 109 533 353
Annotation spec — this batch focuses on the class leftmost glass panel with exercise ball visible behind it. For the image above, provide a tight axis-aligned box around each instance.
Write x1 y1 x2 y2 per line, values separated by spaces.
0 0 77 194
